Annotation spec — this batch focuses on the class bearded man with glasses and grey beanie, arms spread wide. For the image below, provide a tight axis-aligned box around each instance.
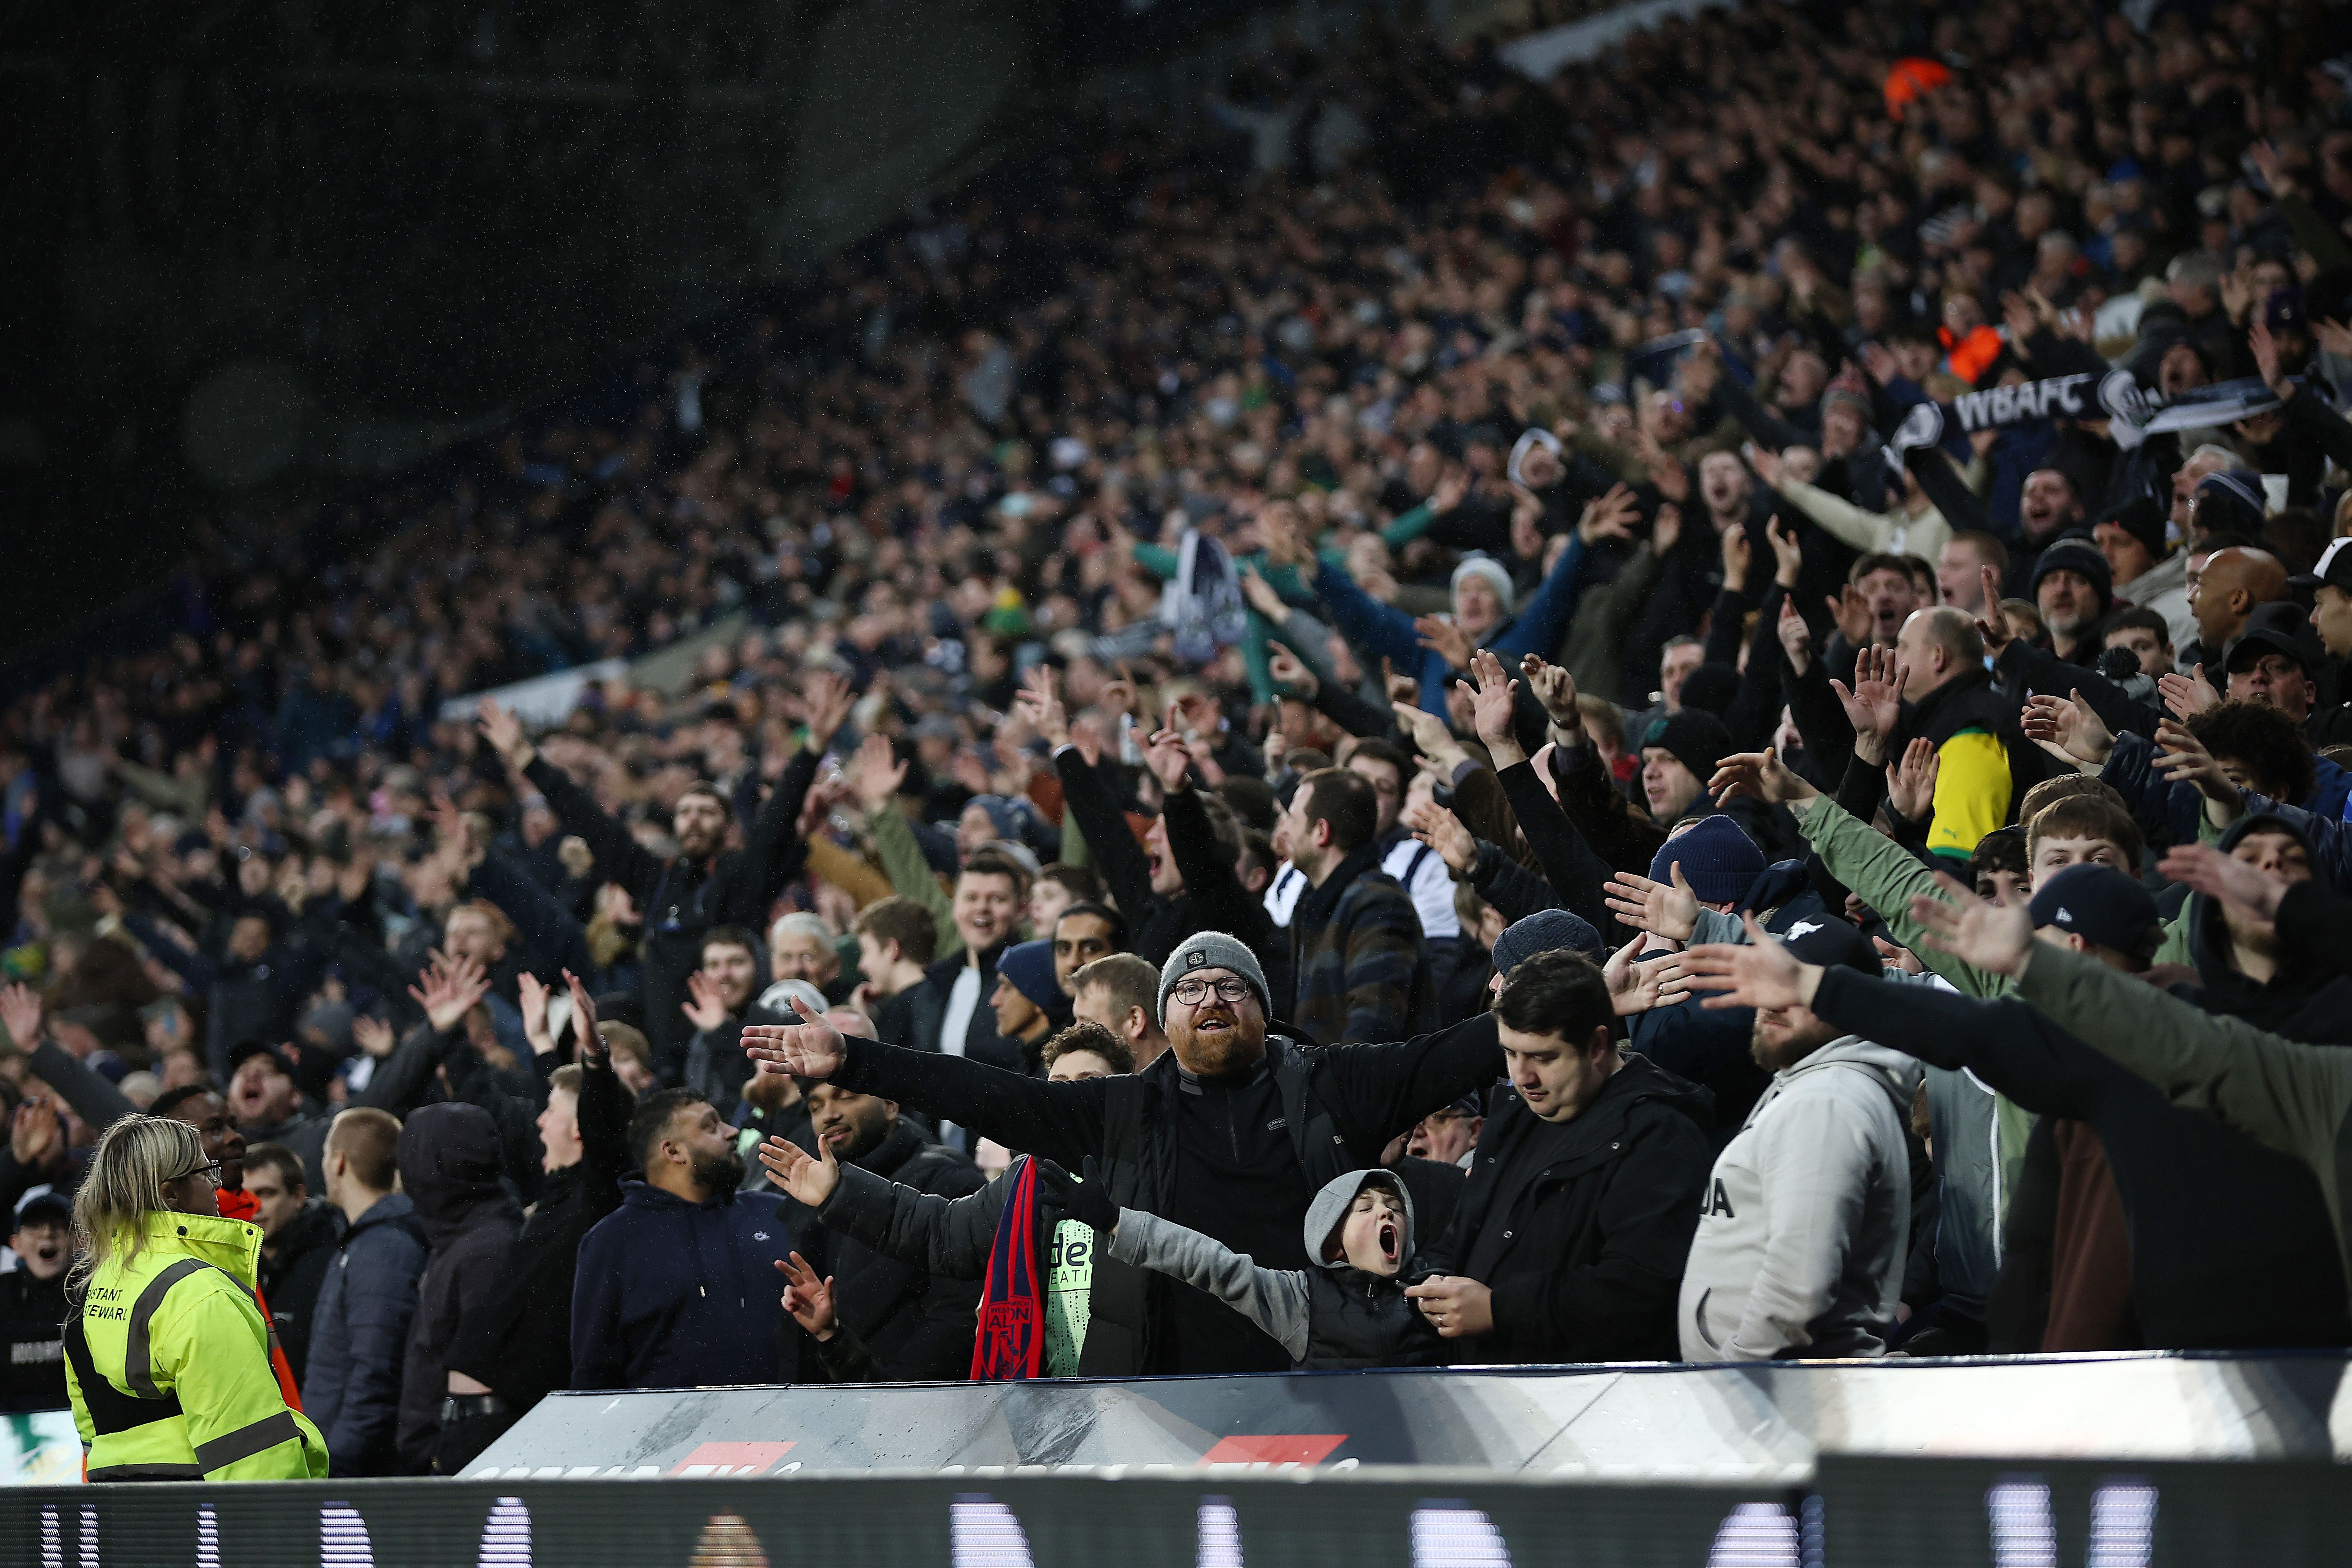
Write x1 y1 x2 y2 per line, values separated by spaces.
743 931 1503 1377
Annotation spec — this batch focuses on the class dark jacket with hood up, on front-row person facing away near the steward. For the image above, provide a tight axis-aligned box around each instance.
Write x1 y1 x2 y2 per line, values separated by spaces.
400 1105 522 1474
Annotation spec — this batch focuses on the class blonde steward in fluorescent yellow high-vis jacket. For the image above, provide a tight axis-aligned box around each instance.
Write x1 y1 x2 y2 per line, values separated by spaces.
66 1117 327 1481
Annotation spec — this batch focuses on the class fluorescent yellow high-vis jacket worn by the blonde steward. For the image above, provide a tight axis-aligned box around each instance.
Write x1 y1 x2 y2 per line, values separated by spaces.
66 1213 327 1481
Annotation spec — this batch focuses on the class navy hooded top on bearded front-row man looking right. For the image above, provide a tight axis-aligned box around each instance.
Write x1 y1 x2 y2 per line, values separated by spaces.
572 1182 807 1389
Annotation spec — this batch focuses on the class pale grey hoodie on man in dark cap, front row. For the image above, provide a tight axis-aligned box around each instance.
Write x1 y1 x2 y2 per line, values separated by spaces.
1675 1034 1919 1361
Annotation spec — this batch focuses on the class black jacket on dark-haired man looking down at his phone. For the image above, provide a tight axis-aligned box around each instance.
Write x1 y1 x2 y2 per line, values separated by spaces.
1421 1056 1715 1363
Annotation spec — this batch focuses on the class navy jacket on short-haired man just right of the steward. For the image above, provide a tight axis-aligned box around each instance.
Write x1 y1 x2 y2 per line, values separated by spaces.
301 1192 426 1476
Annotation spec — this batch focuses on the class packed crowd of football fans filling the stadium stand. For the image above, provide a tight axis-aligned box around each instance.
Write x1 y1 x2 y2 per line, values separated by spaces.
0 0 2352 1476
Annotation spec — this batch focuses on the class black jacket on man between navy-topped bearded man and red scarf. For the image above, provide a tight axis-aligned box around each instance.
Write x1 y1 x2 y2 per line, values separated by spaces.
811 1122 985 1382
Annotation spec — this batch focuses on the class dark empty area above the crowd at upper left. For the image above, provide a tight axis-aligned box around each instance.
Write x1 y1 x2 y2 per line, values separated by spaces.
0 0 1167 668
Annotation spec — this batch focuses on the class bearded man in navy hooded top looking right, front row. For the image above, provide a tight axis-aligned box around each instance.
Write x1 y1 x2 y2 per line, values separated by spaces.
572 1086 809 1389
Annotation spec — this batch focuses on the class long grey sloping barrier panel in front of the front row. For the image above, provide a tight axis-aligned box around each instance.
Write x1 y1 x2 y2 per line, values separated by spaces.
468 1352 2352 1488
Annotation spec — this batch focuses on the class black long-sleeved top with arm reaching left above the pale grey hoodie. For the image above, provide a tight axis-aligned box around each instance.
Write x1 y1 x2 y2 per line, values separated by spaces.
1813 969 2352 1349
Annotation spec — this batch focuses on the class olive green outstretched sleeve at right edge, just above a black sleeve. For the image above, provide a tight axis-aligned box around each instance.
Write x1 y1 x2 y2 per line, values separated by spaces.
2018 943 2352 1276
